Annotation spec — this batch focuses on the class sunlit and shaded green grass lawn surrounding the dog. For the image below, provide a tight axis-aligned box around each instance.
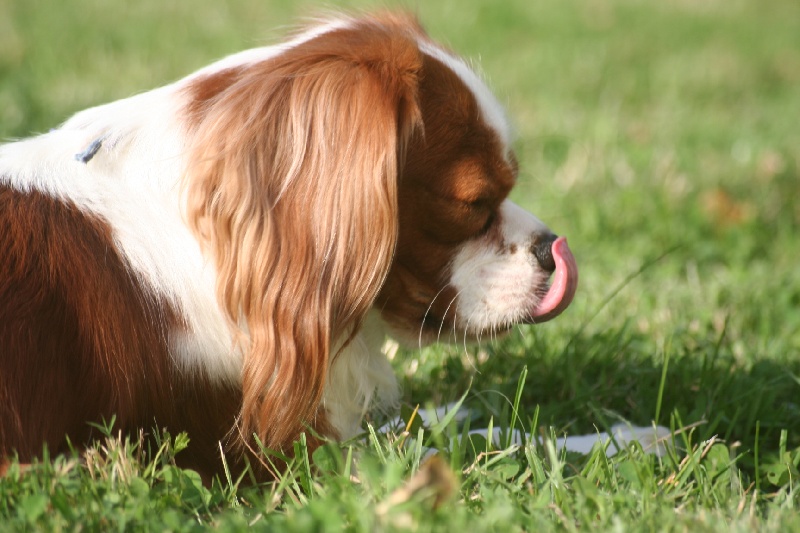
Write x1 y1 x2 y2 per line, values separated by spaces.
0 0 800 531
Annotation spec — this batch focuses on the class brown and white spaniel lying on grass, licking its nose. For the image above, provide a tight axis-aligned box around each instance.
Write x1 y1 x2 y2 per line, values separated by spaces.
0 13 578 476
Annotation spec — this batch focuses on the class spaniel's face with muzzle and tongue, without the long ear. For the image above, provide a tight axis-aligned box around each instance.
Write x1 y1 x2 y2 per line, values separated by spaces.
378 43 577 343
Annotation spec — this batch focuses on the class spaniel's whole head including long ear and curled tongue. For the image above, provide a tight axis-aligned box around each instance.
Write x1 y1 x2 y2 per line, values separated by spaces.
186 12 577 447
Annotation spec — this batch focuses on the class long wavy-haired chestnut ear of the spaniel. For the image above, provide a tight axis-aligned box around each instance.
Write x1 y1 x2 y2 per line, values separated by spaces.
186 16 422 450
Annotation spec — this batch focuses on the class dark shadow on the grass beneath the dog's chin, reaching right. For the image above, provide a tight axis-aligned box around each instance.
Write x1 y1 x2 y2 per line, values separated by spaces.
408 326 800 476
